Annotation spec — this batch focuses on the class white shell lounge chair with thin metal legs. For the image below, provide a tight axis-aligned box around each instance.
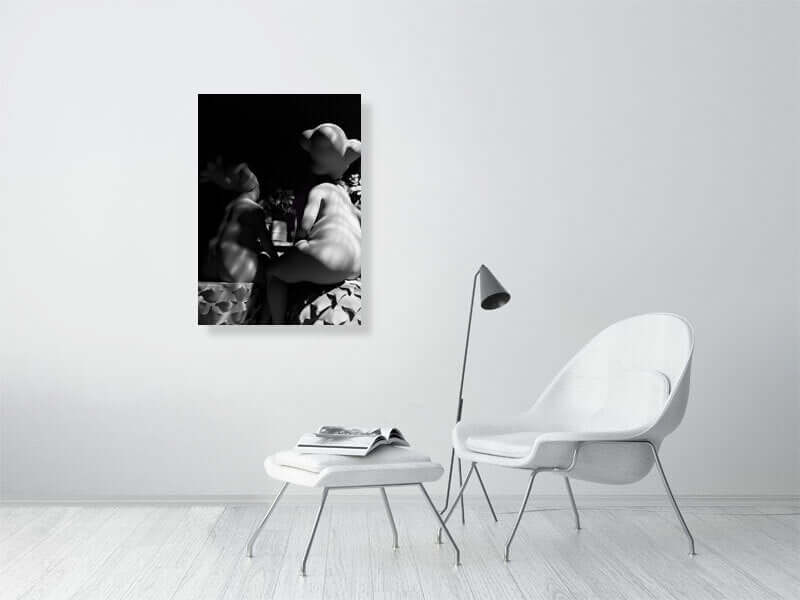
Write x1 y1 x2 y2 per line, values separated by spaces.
439 313 694 560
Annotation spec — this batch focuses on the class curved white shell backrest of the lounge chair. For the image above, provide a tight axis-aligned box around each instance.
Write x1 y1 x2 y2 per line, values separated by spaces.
528 313 694 445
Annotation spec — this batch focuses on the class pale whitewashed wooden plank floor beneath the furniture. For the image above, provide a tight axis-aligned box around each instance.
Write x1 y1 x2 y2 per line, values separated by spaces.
0 490 800 600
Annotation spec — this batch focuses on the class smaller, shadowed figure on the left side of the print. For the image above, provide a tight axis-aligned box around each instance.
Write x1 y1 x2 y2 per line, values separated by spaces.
200 159 273 283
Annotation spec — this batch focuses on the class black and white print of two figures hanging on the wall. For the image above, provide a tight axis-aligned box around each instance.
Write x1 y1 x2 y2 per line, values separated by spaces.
197 94 362 325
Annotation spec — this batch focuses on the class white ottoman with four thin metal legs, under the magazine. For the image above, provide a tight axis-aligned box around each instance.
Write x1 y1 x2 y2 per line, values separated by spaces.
247 446 461 575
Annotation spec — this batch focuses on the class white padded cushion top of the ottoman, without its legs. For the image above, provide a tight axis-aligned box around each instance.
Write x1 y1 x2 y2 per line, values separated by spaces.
264 446 444 487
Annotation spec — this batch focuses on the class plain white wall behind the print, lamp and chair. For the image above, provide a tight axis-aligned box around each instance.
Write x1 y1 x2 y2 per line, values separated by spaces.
0 1 800 499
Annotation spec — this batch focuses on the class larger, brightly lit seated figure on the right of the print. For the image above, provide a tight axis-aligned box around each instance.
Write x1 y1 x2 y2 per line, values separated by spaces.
262 123 361 324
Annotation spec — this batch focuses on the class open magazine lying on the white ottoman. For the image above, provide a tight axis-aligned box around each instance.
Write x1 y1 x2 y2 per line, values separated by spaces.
295 425 408 456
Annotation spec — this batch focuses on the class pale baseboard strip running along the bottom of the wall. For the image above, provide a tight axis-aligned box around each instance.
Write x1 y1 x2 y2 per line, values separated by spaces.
0 488 800 510
